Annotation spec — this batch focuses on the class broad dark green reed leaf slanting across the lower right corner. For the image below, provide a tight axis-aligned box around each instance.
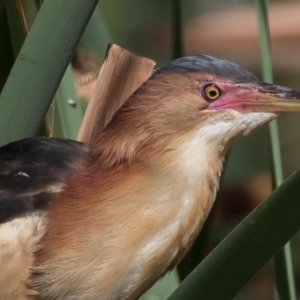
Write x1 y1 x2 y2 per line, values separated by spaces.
168 170 300 300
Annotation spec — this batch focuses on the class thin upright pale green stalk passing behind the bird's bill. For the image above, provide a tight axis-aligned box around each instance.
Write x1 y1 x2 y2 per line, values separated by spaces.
256 0 296 300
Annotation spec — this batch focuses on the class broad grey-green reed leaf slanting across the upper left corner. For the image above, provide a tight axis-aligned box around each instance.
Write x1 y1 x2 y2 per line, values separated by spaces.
0 0 98 145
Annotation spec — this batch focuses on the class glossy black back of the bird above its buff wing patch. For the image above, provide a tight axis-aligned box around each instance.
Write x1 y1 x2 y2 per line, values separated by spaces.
0 138 88 223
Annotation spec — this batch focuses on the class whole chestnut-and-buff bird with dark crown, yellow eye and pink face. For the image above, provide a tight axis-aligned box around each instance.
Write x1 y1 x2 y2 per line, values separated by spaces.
0 55 300 300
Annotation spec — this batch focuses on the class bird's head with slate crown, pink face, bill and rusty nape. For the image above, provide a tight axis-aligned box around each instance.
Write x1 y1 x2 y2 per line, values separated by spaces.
91 55 300 170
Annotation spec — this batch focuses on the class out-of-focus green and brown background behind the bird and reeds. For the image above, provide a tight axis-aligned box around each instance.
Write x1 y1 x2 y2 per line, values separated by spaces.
0 0 300 300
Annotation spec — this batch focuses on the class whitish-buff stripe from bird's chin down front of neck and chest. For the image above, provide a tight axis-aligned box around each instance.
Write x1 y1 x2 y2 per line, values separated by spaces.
123 113 274 298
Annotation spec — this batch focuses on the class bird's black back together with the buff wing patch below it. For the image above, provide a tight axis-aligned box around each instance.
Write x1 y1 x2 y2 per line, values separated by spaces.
0 138 88 300
